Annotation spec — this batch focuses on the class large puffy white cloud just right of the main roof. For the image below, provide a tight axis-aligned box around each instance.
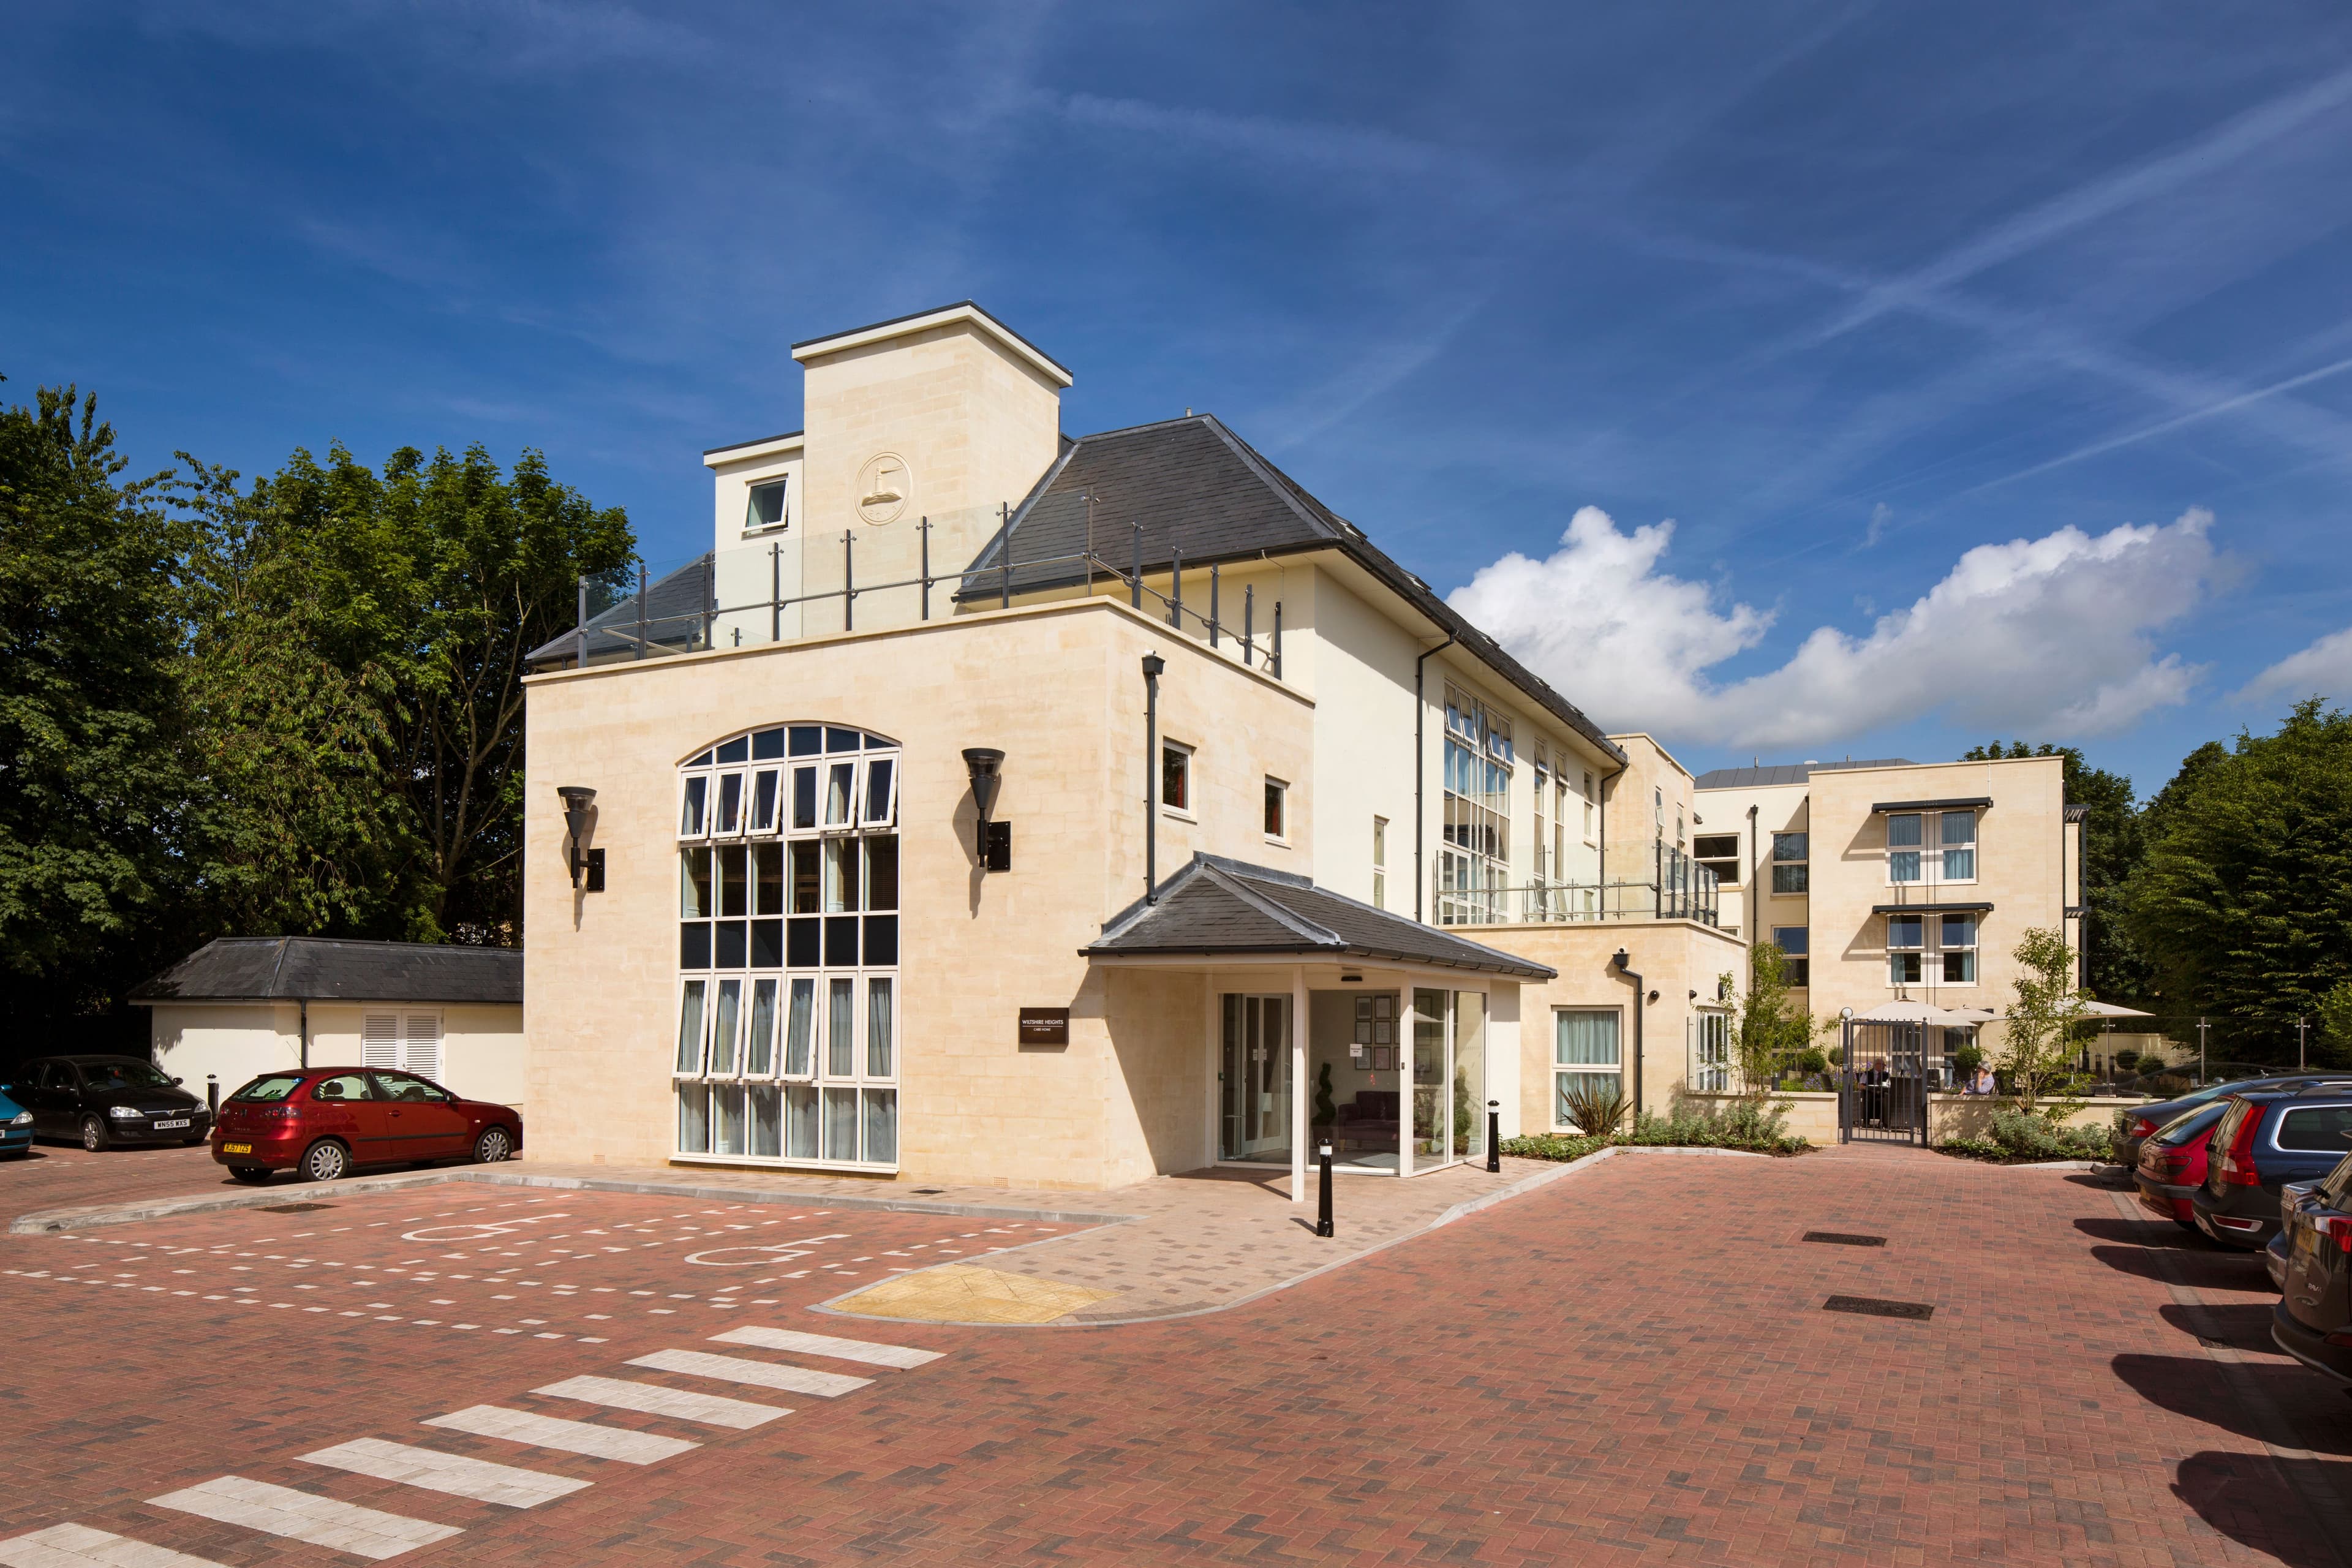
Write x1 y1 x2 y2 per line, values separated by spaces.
1449 505 2220 748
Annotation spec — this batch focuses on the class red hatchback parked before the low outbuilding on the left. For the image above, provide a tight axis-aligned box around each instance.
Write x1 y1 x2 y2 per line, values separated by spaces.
212 1067 522 1183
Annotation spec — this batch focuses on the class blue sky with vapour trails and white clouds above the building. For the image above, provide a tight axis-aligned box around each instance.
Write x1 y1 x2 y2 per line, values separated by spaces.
0 0 2352 792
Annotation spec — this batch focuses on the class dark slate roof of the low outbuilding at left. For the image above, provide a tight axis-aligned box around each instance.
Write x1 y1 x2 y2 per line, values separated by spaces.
129 936 522 1006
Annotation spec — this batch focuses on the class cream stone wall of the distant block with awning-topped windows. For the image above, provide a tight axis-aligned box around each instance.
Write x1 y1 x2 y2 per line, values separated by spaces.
1806 757 2072 1044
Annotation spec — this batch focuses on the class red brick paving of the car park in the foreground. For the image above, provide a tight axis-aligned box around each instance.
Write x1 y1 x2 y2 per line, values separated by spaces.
0 1152 2352 1568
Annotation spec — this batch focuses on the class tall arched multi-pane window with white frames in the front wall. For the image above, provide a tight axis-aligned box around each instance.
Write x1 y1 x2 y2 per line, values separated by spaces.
673 724 899 1170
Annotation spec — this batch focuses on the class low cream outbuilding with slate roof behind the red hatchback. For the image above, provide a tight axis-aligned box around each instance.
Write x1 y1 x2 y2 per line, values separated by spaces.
129 936 529 1110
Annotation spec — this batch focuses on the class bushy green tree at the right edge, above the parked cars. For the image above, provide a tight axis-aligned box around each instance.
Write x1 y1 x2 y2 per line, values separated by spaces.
2128 698 2352 1063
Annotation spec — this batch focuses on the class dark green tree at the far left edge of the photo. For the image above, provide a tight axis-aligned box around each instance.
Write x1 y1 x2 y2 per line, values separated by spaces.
0 385 181 1044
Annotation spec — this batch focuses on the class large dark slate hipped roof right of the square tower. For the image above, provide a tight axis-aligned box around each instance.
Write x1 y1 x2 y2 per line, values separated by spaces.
955 414 1625 762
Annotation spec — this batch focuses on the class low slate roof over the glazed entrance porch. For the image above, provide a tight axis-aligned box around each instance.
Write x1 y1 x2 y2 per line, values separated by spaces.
1080 853 1559 980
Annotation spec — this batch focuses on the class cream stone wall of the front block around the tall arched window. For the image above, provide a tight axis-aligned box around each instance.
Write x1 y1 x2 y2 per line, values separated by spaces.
524 600 1315 1187
